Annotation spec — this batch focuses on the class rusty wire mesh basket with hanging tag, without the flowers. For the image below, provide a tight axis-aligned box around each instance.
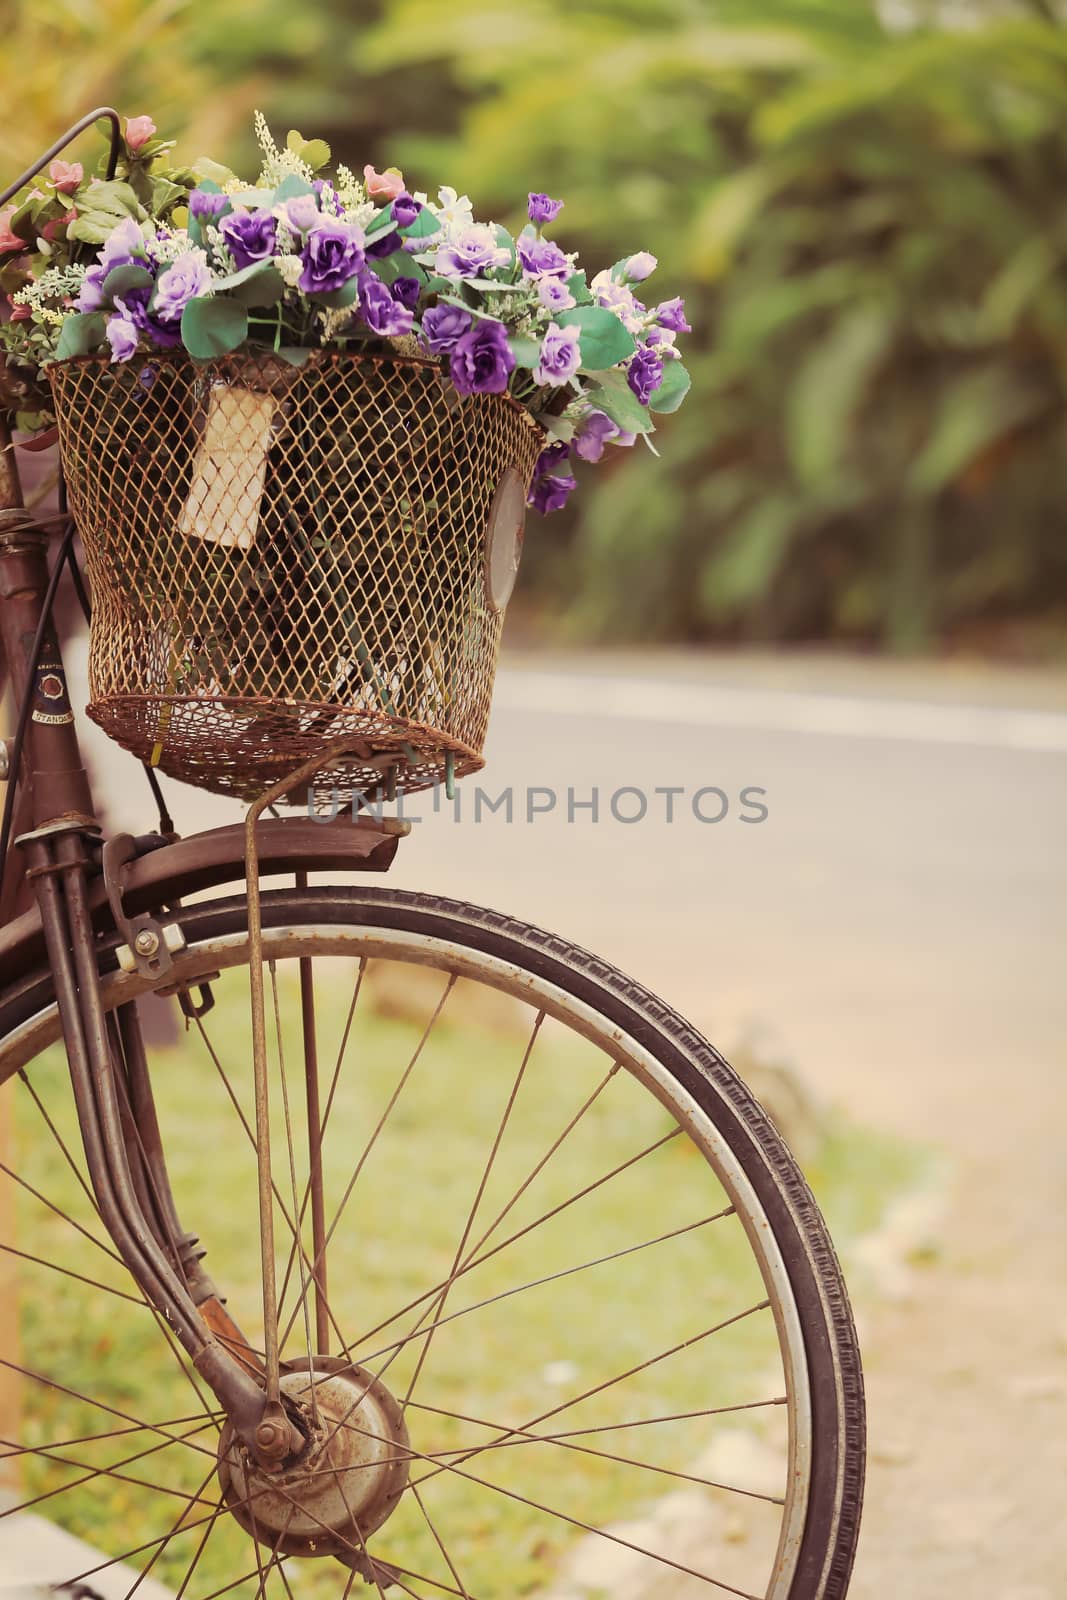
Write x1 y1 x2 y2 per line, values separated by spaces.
50 352 542 798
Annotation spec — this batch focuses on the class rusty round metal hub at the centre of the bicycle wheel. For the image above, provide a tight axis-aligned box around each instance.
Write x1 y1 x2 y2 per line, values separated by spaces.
218 1355 410 1565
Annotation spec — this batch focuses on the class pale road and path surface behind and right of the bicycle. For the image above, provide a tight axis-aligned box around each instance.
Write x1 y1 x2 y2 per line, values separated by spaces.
83 656 1067 1600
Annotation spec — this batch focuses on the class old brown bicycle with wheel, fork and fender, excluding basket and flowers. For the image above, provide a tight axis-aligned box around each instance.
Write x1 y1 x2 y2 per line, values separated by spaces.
0 112 864 1600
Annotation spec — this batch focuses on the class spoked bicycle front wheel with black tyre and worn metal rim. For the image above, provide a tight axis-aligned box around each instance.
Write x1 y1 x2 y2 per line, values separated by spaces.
0 888 864 1600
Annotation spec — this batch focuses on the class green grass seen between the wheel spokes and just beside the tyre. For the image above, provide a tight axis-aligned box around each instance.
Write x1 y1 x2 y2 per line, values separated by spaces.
8 962 915 1600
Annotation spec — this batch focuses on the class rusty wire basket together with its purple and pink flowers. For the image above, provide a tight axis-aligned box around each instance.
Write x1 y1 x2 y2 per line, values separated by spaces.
0 117 689 794
